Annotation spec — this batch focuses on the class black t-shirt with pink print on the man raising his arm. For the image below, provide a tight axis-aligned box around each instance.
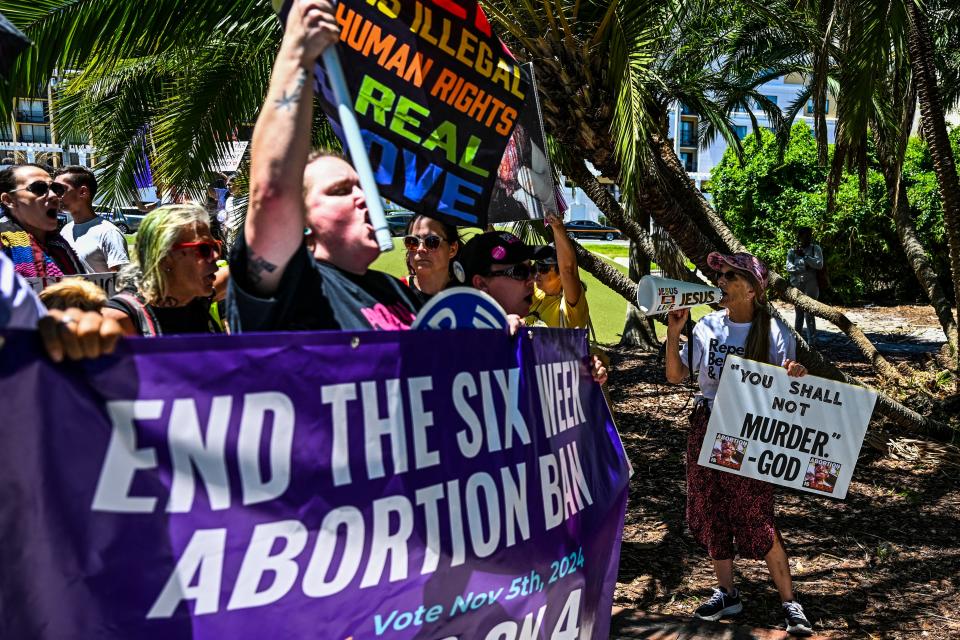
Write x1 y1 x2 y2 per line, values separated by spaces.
227 234 423 333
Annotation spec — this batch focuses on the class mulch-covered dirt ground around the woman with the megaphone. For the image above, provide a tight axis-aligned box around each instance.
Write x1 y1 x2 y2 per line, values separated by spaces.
610 307 960 638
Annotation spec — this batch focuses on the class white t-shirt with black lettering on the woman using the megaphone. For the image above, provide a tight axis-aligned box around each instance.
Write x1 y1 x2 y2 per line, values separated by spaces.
680 309 797 406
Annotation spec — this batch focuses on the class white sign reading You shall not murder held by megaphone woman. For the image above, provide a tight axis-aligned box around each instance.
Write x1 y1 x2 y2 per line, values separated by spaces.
697 353 877 499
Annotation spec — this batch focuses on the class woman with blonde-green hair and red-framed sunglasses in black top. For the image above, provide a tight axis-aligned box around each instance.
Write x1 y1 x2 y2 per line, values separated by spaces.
104 204 226 336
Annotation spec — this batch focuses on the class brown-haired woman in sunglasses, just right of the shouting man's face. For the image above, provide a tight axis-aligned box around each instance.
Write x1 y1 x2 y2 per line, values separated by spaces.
403 215 463 296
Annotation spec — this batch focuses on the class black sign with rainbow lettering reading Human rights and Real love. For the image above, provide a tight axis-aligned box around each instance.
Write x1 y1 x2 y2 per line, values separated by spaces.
281 0 528 227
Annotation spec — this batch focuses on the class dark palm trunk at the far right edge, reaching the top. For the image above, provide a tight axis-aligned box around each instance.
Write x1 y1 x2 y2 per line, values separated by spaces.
906 2 960 376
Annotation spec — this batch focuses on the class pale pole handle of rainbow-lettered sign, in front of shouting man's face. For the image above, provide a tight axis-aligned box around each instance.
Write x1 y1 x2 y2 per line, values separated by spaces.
322 46 393 252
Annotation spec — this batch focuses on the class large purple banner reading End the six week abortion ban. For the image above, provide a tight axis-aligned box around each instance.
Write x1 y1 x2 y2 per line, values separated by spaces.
0 330 628 640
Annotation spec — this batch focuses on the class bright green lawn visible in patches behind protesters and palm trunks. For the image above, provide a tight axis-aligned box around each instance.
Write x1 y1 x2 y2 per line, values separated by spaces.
372 238 710 344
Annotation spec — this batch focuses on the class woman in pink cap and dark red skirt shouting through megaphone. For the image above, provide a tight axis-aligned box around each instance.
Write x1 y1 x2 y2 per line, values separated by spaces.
666 253 812 635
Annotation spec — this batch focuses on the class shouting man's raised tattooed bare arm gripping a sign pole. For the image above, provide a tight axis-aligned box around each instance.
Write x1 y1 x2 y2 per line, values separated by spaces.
244 0 339 295
